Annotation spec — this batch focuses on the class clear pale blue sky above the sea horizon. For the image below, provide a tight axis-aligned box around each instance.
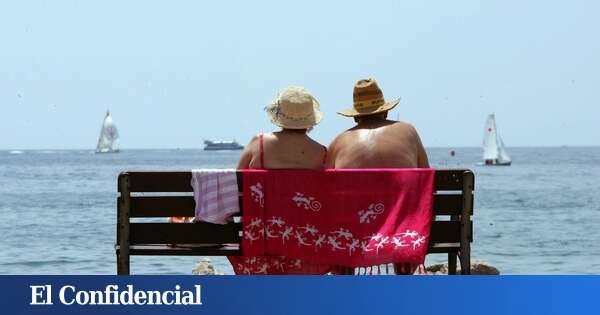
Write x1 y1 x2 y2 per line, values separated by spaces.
0 0 600 149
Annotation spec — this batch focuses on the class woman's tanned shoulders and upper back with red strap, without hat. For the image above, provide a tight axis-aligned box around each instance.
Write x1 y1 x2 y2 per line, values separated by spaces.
237 129 325 169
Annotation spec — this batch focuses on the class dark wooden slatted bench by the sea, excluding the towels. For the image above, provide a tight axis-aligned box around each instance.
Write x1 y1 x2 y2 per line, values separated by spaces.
115 169 474 275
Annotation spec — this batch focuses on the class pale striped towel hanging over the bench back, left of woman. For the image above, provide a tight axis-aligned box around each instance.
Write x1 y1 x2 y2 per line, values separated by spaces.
192 169 240 224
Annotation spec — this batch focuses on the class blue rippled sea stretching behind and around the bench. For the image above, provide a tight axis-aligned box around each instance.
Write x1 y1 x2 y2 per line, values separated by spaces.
0 147 600 275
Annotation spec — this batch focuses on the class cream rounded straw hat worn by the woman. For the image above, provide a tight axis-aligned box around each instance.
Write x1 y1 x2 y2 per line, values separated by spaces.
265 86 323 129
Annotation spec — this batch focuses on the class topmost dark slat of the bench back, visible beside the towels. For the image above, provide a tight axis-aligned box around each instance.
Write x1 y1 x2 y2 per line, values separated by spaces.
119 170 466 192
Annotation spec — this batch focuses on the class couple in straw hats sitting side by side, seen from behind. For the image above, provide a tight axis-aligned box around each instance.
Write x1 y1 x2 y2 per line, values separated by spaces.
238 79 429 169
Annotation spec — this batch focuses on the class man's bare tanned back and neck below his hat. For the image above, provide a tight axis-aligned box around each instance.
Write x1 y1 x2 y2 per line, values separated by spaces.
327 112 429 168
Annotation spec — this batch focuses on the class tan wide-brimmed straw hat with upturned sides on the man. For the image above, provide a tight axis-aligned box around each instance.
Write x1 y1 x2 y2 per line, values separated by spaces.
338 79 400 117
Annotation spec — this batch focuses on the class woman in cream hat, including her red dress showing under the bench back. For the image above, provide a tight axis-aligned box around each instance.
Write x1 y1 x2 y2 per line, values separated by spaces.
229 86 331 274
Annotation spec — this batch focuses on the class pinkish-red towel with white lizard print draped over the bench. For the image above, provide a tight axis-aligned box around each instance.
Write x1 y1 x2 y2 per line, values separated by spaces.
230 169 434 274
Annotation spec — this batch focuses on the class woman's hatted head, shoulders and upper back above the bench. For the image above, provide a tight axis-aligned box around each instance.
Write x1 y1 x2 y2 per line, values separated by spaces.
237 86 327 169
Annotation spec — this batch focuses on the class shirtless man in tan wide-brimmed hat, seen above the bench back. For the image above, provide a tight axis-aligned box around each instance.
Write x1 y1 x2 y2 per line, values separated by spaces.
327 79 429 168
